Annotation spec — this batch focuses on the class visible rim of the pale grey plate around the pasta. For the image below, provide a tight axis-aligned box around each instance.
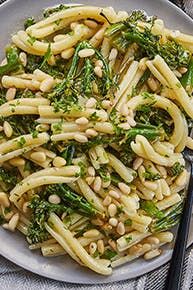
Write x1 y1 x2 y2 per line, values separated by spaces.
0 0 193 284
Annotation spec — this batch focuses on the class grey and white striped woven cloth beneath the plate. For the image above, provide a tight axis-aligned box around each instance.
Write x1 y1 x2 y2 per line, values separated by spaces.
0 0 193 290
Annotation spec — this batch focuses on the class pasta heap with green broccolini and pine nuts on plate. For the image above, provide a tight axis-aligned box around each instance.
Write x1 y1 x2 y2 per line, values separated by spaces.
0 5 193 275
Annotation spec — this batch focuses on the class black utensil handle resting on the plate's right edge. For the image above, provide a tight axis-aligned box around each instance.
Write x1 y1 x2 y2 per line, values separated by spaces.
164 164 193 290
